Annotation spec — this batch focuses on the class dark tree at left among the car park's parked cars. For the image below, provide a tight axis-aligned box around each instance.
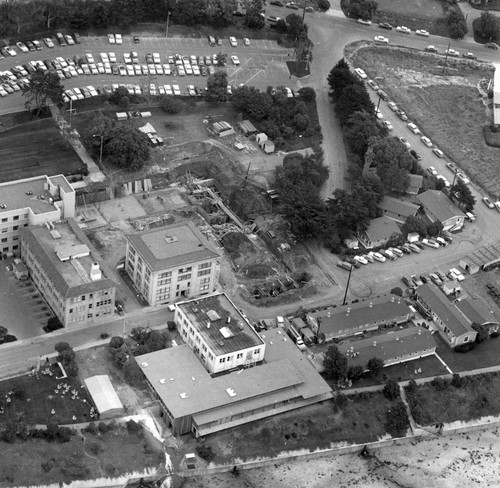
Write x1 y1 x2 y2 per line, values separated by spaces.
22 69 64 117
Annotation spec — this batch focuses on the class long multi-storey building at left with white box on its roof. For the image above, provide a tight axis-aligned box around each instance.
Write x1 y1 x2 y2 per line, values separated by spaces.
21 219 117 327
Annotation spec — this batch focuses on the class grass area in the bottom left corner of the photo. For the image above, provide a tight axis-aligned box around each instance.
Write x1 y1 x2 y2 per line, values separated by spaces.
0 427 162 488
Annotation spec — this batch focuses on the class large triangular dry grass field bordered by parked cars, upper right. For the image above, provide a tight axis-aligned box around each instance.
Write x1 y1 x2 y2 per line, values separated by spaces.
352 47 500 197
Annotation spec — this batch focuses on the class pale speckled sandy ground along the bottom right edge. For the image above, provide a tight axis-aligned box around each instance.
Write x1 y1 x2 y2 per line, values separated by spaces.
184 428 500 488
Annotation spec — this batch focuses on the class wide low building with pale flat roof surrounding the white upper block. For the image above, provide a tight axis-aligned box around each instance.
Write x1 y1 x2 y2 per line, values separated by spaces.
137 329 332 437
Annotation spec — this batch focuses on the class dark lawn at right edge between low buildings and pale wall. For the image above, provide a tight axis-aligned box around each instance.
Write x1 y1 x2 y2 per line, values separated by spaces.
432 334 500 376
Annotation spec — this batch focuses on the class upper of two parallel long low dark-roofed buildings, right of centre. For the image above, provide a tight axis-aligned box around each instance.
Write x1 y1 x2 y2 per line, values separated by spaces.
306 295 411 341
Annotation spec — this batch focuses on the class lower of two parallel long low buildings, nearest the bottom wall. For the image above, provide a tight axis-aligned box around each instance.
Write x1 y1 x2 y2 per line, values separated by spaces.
339 327 436 368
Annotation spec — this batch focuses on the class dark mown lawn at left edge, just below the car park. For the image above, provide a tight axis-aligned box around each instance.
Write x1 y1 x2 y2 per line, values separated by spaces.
0 119 83 182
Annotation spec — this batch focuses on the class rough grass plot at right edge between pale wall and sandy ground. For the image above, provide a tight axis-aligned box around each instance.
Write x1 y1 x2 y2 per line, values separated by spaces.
406 373 500 425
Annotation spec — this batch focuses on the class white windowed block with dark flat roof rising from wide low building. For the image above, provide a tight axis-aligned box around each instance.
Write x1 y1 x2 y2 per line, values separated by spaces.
174 293 266 374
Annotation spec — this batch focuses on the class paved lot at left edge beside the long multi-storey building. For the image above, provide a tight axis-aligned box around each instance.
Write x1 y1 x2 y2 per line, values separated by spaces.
0 260 52 340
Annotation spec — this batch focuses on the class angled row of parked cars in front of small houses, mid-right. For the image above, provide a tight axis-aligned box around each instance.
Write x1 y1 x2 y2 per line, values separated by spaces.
337 235 453 271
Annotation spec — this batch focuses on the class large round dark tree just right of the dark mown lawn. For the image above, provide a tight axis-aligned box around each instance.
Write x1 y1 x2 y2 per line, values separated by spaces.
103 125 149 171
